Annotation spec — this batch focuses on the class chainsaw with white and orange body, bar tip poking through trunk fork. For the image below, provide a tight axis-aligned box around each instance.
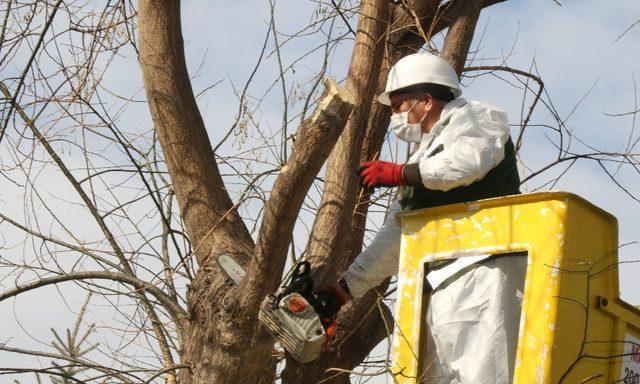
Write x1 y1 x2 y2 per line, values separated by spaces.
218 254 337 364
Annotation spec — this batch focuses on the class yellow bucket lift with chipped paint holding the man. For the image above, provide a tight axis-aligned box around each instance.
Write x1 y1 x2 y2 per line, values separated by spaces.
391 192 640 384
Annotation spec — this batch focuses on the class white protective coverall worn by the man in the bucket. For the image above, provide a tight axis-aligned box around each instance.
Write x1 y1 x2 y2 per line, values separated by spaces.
343 98 526 384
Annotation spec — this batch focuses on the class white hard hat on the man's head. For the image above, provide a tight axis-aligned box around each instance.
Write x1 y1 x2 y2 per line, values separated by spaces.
378 52 462 105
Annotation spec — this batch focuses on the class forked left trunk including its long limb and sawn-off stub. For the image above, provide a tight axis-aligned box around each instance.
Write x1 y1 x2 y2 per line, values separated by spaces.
138 0 353 383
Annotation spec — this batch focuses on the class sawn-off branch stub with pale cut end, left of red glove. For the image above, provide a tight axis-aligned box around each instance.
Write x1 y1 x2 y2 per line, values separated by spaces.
241 79 354 315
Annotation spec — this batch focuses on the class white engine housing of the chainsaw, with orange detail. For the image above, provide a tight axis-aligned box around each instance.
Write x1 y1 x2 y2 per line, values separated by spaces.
258 293 327 364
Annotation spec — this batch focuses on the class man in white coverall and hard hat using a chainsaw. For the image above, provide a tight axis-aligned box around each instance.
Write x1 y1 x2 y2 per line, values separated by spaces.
318 53 526 384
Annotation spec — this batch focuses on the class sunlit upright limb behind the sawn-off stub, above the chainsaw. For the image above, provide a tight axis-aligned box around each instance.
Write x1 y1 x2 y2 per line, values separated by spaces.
307 0 389 282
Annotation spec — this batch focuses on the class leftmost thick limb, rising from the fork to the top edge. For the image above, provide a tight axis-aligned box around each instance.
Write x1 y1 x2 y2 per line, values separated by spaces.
139 0 253 265
